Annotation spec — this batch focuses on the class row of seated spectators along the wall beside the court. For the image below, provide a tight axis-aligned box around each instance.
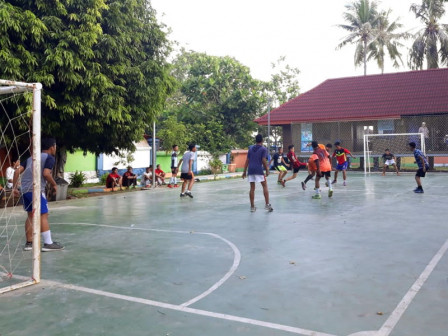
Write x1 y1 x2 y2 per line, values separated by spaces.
106 164 166 191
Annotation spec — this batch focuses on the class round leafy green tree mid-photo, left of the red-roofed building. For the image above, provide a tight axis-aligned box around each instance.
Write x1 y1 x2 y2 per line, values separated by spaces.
166 50 264 154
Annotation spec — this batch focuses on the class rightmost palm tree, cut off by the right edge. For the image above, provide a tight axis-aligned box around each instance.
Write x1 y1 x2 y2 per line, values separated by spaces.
409 0 448 69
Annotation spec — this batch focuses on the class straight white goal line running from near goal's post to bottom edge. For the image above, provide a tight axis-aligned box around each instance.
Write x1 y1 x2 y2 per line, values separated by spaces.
41 280 336 336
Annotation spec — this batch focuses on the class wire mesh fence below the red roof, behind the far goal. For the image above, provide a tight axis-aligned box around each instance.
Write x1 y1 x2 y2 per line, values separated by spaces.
274 114 448 171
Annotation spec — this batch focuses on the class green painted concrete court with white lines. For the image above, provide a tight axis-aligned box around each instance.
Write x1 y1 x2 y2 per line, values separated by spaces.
0 172 448 336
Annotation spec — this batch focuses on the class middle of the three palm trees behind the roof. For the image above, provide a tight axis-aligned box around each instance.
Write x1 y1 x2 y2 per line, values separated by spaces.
367 9 409 73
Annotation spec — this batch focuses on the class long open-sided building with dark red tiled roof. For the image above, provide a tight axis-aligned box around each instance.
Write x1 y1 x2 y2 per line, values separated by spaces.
255 69 448 156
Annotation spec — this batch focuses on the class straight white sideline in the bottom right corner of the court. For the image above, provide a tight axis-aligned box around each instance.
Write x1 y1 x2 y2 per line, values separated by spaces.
375 236 448 336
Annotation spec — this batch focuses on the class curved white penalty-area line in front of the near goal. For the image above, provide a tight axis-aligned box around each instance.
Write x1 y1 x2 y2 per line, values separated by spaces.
52 223 241 307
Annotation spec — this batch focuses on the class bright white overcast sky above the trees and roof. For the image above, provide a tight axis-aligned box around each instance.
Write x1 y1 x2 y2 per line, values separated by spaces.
151 0 448 92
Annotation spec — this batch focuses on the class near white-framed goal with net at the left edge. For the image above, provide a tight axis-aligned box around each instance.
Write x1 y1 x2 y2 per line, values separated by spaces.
0 79 42 293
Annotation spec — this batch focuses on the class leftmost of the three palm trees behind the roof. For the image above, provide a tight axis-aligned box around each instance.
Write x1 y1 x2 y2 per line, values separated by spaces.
337 0 378 76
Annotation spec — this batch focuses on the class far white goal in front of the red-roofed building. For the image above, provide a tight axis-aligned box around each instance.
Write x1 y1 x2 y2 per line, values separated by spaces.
364 133 426 174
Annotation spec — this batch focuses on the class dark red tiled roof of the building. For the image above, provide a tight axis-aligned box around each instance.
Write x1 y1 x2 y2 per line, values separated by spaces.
255 69 448 125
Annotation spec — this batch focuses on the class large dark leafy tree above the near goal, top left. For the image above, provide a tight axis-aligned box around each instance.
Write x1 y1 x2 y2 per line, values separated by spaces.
0 0 175 173
